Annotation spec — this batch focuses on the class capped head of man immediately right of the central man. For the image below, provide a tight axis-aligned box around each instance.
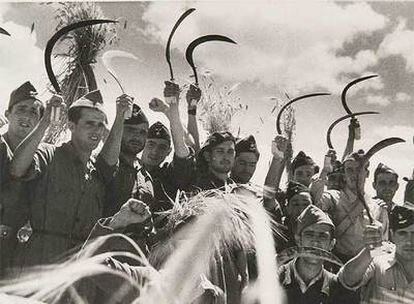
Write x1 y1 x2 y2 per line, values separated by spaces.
230 135 260 184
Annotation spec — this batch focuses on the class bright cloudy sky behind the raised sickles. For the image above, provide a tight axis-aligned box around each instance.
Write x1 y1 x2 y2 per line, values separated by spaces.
0 1 414 201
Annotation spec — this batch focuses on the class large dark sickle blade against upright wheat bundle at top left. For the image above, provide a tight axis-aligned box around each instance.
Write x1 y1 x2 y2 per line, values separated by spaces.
44 19 117 94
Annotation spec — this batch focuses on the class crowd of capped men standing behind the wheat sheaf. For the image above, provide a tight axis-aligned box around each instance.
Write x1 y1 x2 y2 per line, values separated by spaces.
0 82 414 303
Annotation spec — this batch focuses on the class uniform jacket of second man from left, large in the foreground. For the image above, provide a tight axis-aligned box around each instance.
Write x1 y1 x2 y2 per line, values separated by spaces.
12 142 116 266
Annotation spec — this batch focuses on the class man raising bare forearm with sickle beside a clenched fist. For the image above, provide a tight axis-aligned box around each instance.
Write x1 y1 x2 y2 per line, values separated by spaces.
142 81 195 217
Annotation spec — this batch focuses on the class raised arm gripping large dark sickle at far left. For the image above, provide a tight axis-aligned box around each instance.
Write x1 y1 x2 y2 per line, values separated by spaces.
10 95 63 178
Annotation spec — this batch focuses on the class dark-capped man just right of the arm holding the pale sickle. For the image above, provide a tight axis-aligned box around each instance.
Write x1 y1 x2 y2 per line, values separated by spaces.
104 104 154 217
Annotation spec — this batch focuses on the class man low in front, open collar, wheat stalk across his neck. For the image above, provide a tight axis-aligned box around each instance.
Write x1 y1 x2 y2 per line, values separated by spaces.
279 205 354 304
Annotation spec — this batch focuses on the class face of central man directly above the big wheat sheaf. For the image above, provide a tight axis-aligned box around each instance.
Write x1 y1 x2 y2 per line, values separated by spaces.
205 141 235 174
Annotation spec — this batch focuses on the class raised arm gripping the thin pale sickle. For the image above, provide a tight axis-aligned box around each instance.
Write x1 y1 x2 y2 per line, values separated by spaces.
100 94 134 166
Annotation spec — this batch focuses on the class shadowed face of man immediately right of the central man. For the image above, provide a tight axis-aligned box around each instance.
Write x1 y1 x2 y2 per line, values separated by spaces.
231 152 258 184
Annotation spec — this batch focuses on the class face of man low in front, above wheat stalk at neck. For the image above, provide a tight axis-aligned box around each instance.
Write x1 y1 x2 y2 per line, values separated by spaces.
295 224 335 264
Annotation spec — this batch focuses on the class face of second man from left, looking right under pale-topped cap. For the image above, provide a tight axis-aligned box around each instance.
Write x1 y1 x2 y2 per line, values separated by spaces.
69 108 106 152
